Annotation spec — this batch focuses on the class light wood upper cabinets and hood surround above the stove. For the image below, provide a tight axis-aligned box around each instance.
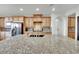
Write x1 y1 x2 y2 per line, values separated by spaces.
24 14 51 28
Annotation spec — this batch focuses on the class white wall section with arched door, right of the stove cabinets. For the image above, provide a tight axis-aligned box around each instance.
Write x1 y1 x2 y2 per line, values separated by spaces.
51 14 68 36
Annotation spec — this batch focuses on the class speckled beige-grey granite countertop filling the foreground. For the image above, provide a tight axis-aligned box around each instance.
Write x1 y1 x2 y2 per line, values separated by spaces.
0 35 79 54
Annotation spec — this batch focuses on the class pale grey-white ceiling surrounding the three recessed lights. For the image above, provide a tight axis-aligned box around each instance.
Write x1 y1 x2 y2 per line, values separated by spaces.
0 4 79 16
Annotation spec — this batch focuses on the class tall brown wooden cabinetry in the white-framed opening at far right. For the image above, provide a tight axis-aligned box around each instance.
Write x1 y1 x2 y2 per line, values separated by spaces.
68 17 75 39
